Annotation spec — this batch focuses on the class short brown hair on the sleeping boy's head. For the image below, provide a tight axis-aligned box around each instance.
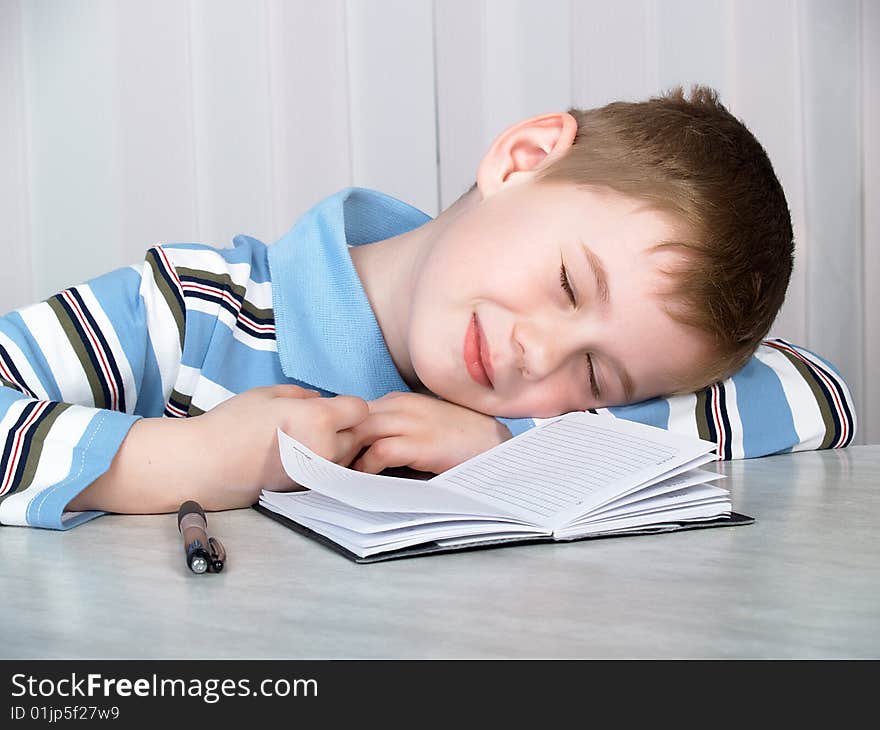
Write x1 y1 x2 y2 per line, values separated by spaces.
539 86 794 390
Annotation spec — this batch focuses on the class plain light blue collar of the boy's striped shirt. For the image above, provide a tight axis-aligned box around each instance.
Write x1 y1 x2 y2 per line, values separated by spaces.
269 188 431 400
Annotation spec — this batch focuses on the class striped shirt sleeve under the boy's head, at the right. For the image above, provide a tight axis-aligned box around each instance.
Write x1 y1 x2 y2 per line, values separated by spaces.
512 338 857 461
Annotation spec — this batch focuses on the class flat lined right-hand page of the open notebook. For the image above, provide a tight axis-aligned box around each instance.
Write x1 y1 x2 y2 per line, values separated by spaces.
431 412 714 528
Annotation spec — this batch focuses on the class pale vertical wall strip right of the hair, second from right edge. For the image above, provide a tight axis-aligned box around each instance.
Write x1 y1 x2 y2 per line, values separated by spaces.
800 0 864 438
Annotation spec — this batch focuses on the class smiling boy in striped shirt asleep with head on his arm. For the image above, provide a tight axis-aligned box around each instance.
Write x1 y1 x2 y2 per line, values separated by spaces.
0 87 852 529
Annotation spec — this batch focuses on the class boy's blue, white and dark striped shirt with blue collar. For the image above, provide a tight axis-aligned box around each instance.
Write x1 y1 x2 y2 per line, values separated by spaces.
0 188 855 529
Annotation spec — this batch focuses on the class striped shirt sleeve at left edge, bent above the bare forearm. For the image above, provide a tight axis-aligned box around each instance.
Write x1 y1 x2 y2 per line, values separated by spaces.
0 247 185 529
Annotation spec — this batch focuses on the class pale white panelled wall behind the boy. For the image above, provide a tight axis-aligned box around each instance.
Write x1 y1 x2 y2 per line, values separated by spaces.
0 0 880 443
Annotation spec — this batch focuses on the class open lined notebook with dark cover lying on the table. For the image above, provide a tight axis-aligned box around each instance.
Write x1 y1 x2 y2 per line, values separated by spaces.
254 412 754 562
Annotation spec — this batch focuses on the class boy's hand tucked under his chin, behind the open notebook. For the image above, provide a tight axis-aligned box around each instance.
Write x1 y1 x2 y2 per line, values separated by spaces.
351 392 511 474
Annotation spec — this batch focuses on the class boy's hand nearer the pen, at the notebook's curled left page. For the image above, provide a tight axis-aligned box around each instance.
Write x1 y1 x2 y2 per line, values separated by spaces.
189 385 369 500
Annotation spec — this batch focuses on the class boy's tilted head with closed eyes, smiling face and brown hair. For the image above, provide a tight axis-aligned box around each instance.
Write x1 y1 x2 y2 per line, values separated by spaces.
396 87 793 416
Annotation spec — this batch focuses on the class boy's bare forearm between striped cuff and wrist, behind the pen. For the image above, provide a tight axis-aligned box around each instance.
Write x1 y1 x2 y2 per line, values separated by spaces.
67 418 232 514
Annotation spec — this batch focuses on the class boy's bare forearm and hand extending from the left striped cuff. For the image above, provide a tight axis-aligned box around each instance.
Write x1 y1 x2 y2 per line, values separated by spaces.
67 385 369 514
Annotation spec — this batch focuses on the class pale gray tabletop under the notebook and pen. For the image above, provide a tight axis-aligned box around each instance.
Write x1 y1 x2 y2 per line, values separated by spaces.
0 446 880 658
